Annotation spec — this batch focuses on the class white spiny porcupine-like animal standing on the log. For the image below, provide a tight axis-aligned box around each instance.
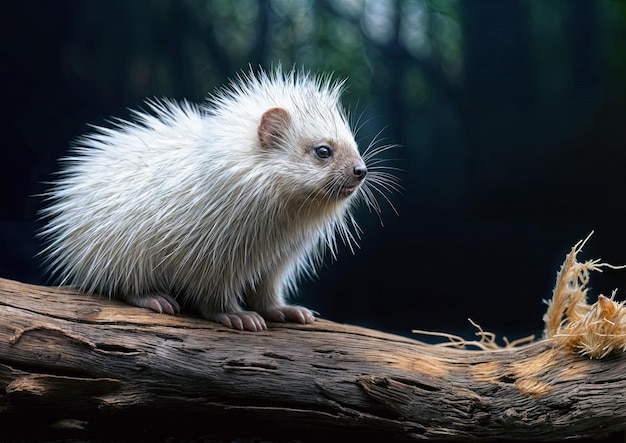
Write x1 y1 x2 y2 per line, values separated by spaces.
40 68 397 331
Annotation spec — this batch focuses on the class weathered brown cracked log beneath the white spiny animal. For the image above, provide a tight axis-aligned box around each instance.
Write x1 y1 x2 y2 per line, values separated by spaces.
0 279 626 441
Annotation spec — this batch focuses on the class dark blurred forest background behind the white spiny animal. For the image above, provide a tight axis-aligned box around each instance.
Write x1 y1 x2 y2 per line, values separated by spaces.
0 0 626 344
